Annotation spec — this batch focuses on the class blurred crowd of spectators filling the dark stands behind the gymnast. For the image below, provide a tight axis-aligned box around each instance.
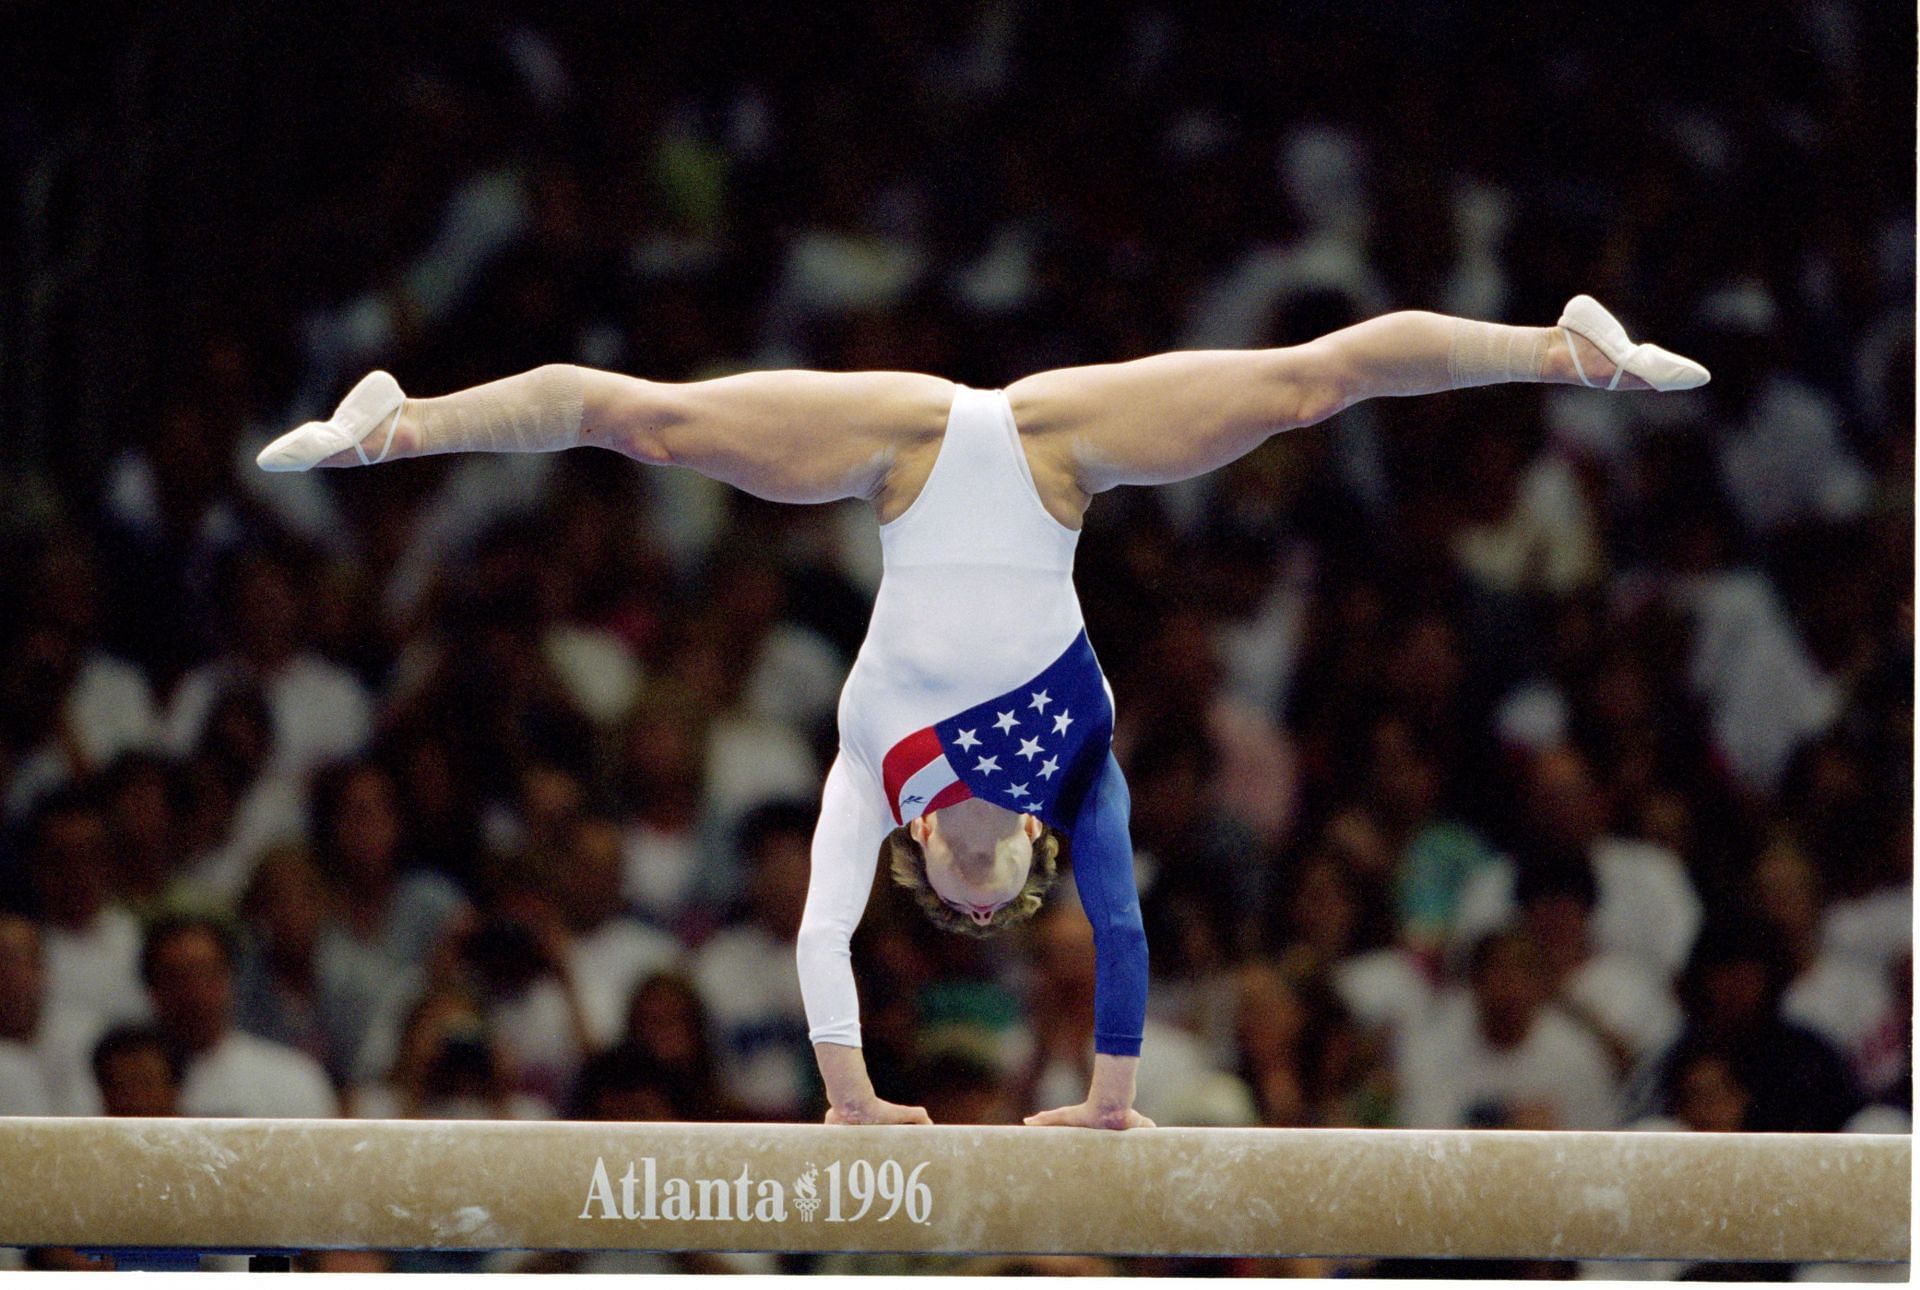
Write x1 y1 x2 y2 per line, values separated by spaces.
0 0 1914 1275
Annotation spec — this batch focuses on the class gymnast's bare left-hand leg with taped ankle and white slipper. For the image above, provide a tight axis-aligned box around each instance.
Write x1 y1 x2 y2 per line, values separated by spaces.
261 363 954 503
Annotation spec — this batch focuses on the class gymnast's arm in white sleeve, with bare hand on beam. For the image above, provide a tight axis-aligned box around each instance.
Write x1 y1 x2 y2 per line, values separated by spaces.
795 753 933 1125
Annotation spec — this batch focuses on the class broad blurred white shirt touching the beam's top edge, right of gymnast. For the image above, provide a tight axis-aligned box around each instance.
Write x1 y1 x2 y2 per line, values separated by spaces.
1396 991 1617 1129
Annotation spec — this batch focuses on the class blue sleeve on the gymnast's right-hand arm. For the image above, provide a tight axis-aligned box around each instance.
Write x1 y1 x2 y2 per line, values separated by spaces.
1068 753 1146 1058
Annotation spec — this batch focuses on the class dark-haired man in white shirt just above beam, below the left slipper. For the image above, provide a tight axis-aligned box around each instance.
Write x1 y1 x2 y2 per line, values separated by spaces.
140 916 340 1119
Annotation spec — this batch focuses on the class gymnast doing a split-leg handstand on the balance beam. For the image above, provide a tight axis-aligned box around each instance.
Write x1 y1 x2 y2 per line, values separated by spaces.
259 296 1707 1129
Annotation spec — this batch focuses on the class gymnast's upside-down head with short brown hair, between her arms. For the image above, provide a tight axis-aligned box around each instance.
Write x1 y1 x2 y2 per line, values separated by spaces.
883 797 1064 937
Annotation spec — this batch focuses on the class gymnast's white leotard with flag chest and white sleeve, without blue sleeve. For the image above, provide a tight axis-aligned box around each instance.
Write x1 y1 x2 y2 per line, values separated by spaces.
799 386 1131 1046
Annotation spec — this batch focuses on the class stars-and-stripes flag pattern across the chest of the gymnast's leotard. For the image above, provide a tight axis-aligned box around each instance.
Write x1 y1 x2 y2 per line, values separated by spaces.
879 630 1114 827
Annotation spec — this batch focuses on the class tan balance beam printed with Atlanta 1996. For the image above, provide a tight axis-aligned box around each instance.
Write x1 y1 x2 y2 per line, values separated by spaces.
0 1119 1912 1261
